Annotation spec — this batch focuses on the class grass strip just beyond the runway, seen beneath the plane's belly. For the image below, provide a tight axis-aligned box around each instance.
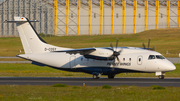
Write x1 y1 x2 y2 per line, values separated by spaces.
0 64 180 77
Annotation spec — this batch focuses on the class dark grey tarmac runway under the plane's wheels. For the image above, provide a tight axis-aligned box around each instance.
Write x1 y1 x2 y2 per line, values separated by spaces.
0 77 180 87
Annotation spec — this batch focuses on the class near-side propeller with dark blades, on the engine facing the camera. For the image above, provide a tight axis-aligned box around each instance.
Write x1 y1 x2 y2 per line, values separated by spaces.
110 39 122 70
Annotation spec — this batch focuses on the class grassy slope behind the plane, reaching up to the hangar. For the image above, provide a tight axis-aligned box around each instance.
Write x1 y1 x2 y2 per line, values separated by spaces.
0 28 180 57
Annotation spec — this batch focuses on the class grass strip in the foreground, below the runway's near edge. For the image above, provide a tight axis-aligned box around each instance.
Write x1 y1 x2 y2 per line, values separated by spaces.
0 85 180 101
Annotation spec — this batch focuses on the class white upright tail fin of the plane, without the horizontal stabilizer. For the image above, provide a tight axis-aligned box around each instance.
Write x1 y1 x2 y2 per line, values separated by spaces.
14 17 45 54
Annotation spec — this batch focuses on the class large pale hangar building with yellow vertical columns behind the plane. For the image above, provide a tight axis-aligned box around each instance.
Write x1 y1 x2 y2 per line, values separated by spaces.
0 0 180 37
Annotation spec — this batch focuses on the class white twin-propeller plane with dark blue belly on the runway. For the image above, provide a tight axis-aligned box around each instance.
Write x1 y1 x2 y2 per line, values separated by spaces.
5 17 176 79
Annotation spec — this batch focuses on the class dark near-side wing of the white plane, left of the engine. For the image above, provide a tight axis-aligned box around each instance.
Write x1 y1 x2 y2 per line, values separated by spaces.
53 48 96 55
